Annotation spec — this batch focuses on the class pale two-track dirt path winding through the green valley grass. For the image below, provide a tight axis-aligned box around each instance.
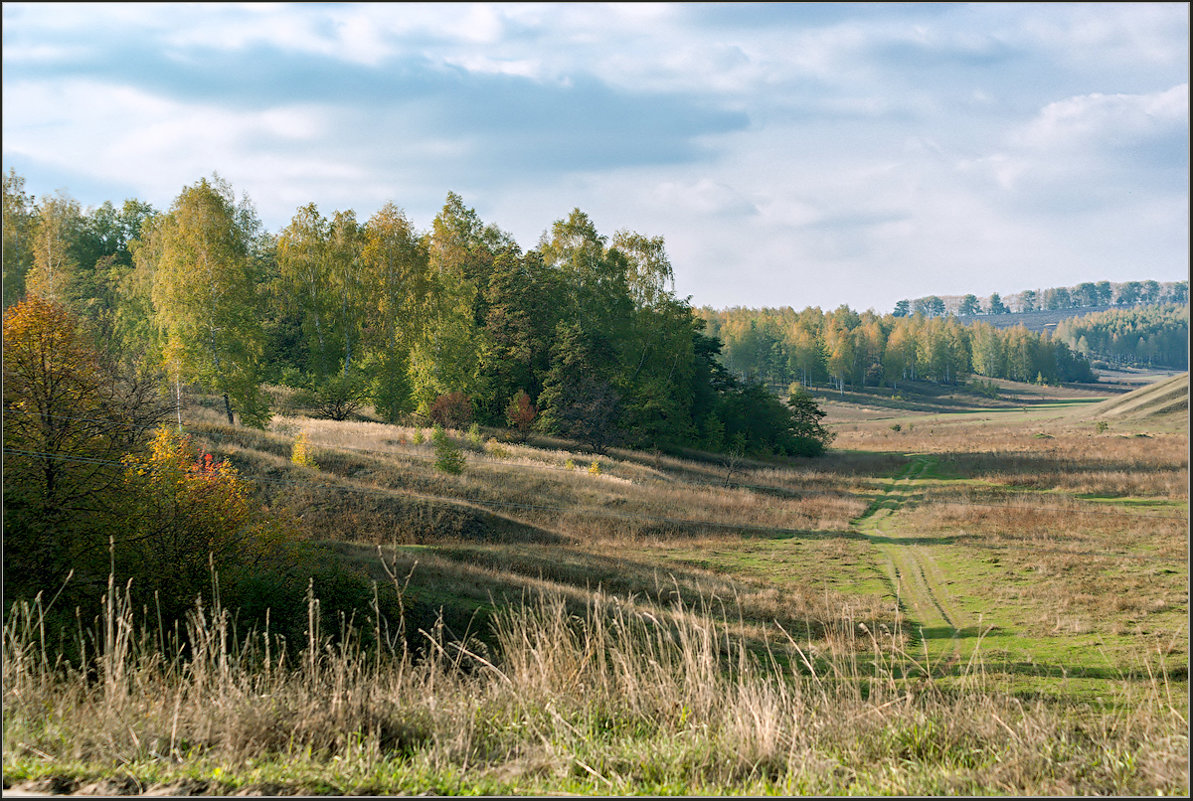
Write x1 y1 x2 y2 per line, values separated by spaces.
853 456 976 661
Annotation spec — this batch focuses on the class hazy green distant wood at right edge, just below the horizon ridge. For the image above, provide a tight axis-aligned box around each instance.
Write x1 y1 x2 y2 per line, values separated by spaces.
1053 306 1189 370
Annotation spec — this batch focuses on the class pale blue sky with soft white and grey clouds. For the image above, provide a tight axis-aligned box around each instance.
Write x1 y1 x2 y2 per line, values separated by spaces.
2 2 1189 313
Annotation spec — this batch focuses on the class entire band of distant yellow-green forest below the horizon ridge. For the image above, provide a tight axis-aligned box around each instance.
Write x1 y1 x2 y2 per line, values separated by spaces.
699 300 1188 390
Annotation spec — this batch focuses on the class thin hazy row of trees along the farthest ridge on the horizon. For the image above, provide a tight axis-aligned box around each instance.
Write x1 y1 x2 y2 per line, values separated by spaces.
894 281 1189 318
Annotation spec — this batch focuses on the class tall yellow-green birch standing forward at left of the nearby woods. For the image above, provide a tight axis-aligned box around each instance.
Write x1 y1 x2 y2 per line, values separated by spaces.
137 177 268 426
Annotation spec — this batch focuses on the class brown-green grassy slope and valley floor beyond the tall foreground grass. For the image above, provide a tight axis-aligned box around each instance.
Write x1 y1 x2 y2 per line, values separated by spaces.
181 380 1187 695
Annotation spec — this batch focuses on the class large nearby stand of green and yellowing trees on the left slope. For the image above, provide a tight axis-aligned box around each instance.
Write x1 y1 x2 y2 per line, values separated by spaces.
4 171 830 455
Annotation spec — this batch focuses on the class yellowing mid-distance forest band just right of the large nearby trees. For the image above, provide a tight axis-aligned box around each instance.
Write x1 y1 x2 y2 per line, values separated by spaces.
700 306 1094 390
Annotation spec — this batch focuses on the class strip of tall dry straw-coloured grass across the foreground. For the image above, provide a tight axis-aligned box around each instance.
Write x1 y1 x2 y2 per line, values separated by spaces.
4 577 1188 795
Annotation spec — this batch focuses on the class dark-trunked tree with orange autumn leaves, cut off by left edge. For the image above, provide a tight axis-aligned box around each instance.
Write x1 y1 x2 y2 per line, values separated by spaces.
4 295 165 597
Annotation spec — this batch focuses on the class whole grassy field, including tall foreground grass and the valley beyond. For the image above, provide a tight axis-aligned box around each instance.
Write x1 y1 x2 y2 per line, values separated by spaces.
4 376 1189 795
